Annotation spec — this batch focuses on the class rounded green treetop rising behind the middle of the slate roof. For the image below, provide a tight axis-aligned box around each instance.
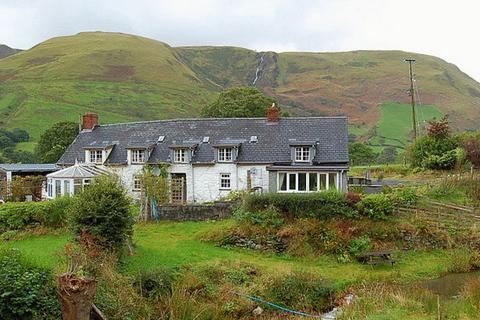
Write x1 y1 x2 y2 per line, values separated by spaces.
201 87 275 118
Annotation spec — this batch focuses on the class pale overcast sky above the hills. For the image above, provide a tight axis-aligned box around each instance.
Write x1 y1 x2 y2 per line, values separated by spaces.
0 0 480 81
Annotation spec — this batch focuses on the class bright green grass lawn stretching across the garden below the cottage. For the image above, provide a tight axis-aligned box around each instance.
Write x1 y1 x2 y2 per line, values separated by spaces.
0 220 456 283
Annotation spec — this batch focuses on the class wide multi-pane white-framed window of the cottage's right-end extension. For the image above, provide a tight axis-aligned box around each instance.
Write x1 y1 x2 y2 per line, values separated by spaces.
277 172 339 192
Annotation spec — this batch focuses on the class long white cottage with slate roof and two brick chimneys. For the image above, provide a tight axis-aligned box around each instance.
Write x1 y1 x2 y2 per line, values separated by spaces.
57 106 348 202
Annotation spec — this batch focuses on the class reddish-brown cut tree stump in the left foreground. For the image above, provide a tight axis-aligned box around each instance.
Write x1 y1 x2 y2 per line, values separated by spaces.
58 273 97 320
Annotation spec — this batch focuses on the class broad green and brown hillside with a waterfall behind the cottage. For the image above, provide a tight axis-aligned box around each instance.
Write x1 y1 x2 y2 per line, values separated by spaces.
0 32 480 148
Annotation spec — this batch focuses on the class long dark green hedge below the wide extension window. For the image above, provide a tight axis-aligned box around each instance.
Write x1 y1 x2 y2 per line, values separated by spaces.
243 191 355 219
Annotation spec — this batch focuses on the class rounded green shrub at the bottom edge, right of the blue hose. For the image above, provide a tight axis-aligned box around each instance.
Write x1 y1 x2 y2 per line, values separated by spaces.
267 273 335 312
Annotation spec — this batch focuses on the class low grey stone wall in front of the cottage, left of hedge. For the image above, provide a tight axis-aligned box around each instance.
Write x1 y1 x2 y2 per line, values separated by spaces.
158 202 233 221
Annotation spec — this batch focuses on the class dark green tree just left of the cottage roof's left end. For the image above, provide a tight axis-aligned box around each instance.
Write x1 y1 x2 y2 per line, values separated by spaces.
35 122 78 163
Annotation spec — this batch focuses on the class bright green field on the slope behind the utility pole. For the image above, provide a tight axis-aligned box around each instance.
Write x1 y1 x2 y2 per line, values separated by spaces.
369 102 443 151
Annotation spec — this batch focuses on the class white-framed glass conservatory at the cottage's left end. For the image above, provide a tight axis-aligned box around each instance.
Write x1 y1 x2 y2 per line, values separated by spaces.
47 163 109 199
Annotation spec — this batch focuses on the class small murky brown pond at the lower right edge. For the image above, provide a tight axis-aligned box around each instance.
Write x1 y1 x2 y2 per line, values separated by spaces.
422 272 480 299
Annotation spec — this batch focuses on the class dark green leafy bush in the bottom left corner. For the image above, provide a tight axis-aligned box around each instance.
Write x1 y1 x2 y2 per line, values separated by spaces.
0 250 61 320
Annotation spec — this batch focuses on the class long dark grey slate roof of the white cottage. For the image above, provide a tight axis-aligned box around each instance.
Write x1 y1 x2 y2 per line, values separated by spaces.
58 117 348 165
